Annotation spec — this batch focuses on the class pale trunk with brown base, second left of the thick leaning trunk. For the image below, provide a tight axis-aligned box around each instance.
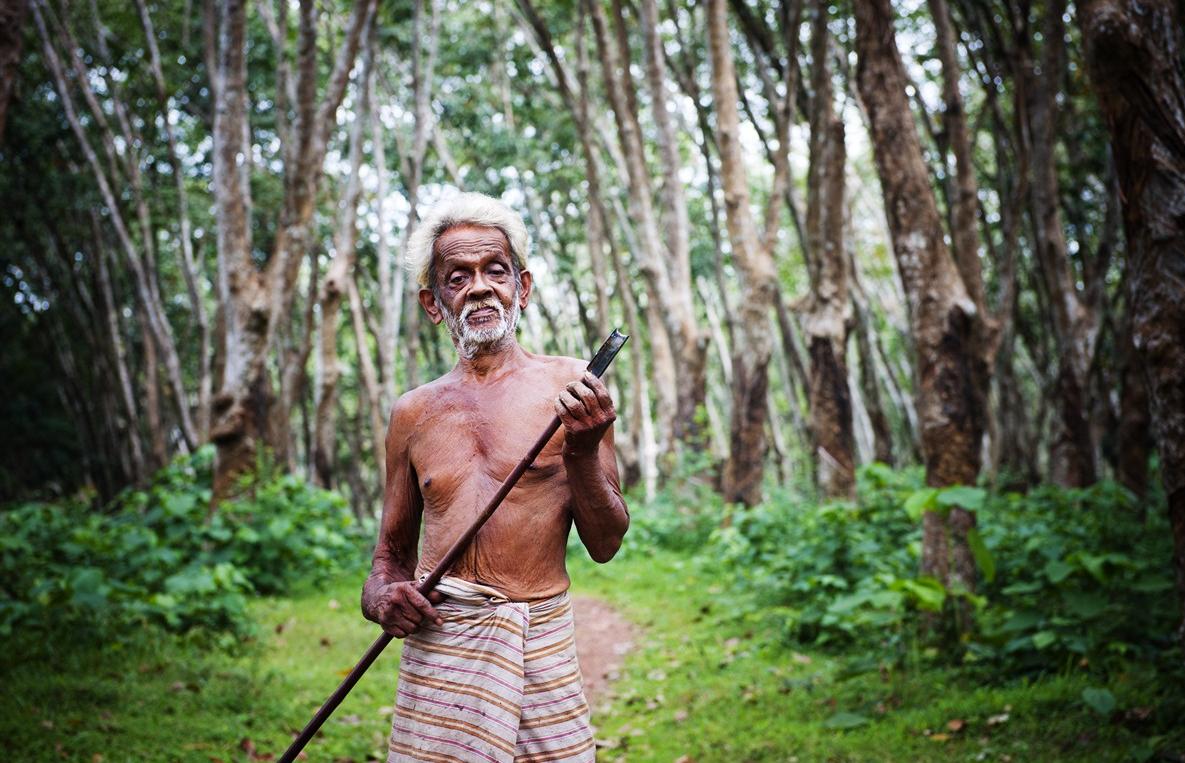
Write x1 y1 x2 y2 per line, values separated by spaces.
707 0 786 506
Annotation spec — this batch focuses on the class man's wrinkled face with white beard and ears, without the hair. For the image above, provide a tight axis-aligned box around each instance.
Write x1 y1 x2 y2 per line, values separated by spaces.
419 225 531 358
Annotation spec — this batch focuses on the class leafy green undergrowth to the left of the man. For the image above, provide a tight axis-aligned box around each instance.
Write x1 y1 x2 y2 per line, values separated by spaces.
0 448 364 635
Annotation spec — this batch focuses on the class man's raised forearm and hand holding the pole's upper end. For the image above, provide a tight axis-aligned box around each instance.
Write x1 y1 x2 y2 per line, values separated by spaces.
556 372 629 563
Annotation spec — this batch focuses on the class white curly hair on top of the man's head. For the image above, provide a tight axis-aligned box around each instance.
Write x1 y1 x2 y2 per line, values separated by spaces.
404 192 531 289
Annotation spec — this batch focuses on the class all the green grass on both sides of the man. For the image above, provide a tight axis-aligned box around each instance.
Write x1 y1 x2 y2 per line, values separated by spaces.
0 551 1185 763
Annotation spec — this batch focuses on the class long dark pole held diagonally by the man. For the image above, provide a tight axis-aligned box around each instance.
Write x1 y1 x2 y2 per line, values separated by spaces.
280 329 629 763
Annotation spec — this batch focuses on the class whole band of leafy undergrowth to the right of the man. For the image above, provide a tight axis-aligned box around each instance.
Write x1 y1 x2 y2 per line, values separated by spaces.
627 464 1177 675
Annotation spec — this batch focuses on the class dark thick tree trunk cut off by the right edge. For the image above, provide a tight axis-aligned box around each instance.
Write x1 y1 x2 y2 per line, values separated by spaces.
1078 0 1185 639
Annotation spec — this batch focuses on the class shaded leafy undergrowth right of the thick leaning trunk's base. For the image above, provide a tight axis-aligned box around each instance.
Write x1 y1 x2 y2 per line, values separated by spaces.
973 482 1179 667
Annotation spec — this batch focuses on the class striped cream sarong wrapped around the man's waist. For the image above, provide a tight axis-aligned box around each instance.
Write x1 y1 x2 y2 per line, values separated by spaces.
387 578 596 763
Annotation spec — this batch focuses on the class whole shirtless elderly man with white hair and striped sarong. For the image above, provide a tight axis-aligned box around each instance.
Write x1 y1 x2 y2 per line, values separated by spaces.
363 193 629 762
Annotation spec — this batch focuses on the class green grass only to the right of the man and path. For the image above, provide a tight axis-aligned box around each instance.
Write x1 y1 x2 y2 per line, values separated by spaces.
574 553 1185 763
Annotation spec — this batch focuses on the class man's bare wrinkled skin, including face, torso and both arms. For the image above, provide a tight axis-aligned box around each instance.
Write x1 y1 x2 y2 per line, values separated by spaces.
363 225 629 639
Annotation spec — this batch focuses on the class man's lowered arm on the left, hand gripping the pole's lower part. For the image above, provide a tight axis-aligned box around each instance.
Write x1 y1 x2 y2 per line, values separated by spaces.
361 398 443 639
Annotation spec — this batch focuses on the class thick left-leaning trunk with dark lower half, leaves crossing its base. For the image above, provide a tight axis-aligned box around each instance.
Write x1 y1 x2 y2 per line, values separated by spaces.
856 0 986 590
